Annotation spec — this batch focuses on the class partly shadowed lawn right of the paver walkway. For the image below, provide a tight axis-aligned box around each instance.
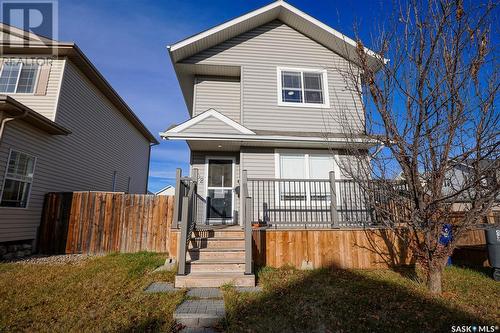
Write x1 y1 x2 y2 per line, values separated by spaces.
224 267 500 332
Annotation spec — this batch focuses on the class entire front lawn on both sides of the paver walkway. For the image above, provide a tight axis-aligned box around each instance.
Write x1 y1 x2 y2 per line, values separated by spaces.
0 253 500 332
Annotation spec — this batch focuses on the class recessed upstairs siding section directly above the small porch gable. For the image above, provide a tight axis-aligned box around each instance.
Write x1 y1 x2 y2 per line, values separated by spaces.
193 77 241 123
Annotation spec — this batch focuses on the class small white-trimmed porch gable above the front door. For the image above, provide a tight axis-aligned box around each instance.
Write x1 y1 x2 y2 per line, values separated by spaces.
160 109 255 137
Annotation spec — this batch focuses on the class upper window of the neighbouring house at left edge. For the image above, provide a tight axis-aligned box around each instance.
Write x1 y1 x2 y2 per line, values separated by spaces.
0 62 38 94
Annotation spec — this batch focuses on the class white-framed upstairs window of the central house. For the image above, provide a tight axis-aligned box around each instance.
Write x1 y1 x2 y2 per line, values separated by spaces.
278 68 329 107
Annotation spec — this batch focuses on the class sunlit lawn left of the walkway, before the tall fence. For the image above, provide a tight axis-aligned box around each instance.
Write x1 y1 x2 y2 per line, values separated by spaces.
0 253 184 332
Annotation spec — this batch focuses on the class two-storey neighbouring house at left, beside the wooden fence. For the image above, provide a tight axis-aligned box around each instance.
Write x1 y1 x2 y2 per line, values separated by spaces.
0 24 157 252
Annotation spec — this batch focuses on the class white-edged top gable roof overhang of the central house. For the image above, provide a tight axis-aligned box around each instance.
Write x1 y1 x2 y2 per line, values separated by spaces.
168 0 386 68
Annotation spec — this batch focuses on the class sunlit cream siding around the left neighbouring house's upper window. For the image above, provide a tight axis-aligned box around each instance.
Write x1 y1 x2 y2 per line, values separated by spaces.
1 55 65 120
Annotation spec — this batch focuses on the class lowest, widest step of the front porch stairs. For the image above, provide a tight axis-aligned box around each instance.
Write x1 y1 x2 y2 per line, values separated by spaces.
174 273 255 288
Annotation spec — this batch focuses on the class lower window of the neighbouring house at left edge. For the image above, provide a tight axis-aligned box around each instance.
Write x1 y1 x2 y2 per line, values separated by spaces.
0 150 36 208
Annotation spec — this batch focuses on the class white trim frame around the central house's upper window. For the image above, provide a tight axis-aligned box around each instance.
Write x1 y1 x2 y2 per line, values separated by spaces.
276 66 330 109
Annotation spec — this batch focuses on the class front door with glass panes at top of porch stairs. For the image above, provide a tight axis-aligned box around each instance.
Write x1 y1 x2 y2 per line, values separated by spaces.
207 157 234 224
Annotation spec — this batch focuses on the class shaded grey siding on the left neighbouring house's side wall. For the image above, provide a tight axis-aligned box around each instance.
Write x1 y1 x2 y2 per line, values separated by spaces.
0 62 149 242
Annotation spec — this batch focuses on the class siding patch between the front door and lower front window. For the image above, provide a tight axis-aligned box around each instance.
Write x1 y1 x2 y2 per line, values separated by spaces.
241 147 276 178
